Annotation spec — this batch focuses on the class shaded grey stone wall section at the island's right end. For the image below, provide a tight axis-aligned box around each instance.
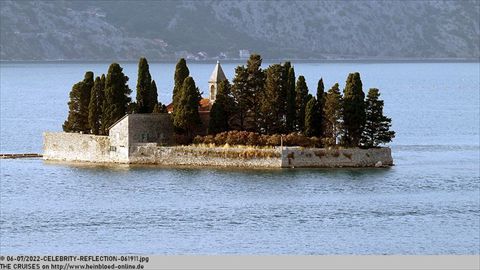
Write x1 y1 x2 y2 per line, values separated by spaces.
282 147 393 168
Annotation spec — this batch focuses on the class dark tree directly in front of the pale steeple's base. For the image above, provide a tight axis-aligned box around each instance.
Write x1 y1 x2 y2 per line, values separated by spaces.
208 80 235 134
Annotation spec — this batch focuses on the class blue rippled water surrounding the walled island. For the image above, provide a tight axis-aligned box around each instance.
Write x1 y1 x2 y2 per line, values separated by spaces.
0 63 480 254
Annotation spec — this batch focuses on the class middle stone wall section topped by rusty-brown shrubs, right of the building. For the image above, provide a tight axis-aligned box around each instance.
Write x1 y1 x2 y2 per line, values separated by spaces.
130 147 281 168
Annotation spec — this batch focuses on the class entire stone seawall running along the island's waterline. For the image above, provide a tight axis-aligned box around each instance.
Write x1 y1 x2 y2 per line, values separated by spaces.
43 132 393 168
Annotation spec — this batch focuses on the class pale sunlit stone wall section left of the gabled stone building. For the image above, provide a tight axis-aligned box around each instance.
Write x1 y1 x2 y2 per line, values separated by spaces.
43 132 112 162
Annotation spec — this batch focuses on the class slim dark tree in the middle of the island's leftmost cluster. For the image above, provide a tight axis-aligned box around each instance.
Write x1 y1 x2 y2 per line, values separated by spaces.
88 74 105 135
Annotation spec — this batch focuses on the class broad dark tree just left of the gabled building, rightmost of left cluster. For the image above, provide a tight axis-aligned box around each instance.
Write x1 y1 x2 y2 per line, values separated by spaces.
101 63 132 134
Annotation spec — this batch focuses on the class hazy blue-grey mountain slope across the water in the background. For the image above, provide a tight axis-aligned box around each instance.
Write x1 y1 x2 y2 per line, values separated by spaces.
0 0 480 60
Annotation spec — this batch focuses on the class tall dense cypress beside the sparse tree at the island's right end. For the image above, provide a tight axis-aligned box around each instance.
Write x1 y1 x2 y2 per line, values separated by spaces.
342 72 365 147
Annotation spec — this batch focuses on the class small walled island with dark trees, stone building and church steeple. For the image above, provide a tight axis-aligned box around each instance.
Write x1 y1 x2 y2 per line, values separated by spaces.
43 54 395 168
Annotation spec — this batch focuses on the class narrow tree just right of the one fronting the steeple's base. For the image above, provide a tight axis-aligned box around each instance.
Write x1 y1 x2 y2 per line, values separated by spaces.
232 66 251 130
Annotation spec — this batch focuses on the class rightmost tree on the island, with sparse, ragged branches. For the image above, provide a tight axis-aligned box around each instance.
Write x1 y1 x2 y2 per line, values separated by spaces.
361 88 395 147
